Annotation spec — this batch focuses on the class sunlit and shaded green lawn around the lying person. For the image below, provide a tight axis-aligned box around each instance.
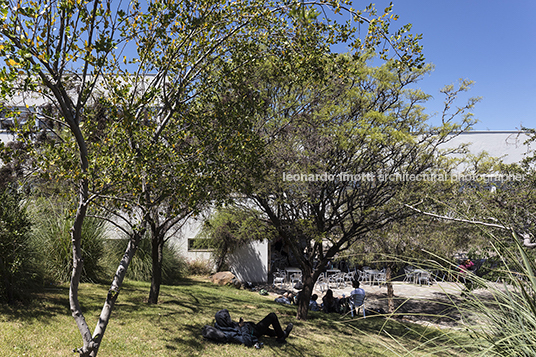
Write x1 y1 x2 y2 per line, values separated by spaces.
0 279 474 357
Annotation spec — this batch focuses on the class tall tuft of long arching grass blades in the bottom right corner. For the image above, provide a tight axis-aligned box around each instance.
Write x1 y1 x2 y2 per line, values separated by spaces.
386 232 536 357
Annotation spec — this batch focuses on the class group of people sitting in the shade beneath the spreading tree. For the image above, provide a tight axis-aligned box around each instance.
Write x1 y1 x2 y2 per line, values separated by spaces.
275 280 365 313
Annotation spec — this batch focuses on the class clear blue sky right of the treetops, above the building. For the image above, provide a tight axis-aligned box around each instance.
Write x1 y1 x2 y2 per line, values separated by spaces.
338 0 536 130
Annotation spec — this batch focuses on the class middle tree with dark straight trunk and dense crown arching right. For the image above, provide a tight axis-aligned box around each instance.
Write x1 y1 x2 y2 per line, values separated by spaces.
79 1 420 303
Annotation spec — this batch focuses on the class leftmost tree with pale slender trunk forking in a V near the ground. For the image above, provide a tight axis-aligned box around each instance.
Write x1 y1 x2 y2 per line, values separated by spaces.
0 0 149 356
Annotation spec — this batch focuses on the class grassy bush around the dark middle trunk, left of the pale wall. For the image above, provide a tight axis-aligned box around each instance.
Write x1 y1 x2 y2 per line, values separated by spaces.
101 238 187 285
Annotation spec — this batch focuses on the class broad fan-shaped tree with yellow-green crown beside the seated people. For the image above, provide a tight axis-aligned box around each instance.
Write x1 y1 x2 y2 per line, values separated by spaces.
249 56 476 319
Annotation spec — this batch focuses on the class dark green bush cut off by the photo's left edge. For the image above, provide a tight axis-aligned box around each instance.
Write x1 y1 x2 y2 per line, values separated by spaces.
0 188 40 303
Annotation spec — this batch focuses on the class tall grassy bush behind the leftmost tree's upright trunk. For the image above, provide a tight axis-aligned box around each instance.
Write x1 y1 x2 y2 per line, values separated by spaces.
28 198 106 282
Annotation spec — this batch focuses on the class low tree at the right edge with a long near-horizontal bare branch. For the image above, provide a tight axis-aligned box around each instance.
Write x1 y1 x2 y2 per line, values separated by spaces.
406 152 536 248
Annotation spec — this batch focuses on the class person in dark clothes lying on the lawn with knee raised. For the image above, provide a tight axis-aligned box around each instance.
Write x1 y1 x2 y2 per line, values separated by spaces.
203 309 294 348
